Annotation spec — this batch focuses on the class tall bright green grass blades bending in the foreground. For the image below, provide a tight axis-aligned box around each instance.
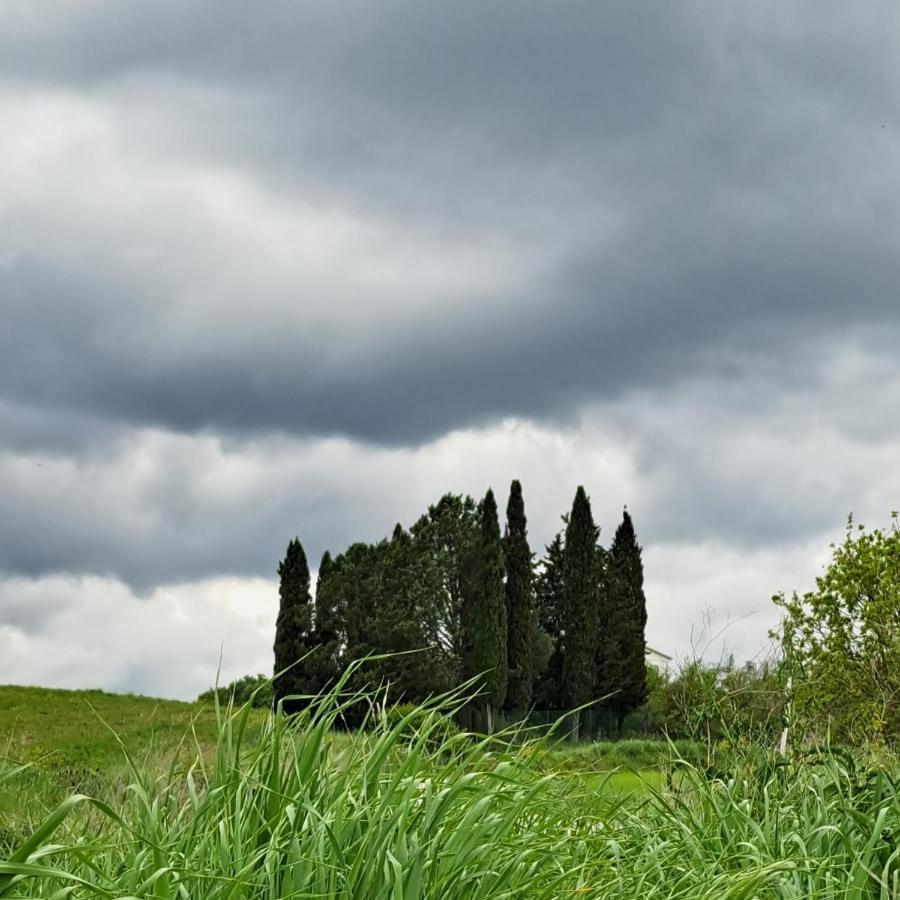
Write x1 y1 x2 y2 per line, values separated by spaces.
0 672 900 900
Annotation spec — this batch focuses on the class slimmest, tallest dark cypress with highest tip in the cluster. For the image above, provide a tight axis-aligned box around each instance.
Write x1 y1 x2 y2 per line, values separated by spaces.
503 479 534 710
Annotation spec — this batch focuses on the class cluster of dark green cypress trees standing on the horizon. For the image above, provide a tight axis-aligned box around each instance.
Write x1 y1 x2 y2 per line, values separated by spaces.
275 481 647 730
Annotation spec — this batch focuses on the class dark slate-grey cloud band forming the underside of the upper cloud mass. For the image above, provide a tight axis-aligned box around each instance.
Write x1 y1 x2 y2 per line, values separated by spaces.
0 203 900 442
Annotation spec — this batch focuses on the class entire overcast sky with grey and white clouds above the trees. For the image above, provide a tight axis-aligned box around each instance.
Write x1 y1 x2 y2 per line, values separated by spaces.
0 0 900 698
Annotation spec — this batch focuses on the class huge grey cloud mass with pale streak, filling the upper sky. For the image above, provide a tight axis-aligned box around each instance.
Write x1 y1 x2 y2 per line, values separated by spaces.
0 3 900 444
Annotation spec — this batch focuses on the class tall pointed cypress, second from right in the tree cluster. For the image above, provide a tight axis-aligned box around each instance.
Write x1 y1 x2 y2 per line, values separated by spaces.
562 485 599 740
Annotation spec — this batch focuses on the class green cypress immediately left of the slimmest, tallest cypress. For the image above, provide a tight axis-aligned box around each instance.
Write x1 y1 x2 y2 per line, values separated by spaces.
466 489 507 731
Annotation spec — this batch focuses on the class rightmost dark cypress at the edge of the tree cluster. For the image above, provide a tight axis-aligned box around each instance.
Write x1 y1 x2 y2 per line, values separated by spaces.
600 510 647 729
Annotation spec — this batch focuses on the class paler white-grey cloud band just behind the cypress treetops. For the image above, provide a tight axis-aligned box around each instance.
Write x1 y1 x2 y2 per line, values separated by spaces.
0 380 900 601
